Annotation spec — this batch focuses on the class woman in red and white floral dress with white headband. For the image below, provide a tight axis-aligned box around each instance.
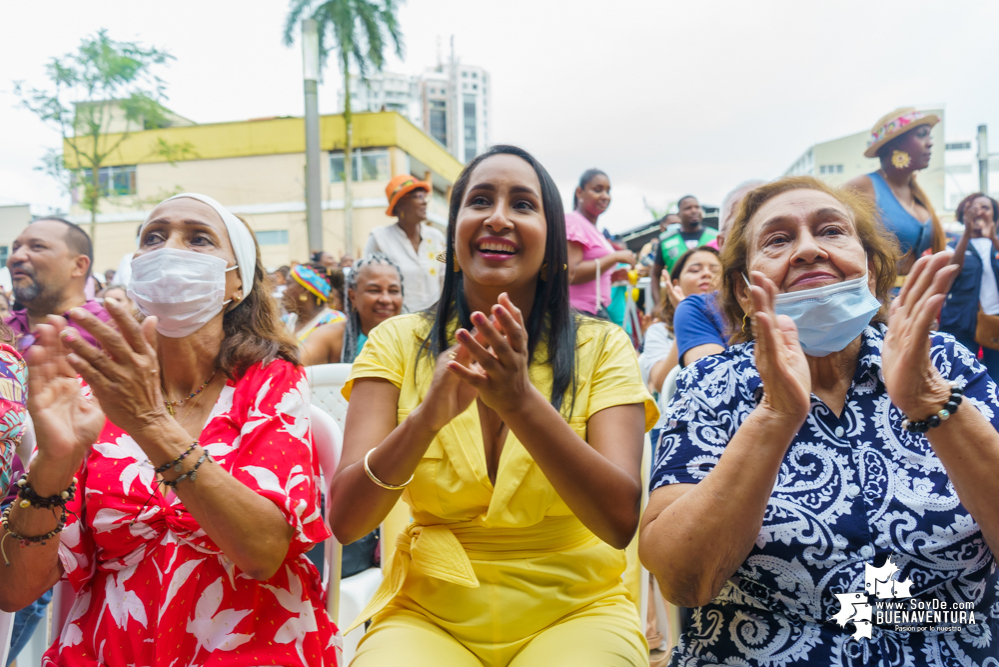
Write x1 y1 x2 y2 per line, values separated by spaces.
0 194 337 667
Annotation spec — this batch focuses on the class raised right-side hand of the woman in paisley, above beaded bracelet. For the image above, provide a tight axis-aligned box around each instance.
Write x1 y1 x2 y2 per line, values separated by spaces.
881 252 960 420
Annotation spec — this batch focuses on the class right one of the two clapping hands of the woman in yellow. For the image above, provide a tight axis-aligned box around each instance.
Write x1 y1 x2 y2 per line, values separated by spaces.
448 293 536 416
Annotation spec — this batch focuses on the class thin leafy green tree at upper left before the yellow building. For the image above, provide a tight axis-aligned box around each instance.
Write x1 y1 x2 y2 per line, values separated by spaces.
14 30 191 247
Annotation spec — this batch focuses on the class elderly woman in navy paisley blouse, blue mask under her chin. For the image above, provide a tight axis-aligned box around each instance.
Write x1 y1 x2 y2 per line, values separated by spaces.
640 177 999 667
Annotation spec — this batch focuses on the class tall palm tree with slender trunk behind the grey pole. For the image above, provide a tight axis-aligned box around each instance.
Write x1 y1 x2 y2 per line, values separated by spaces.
284 0 402 254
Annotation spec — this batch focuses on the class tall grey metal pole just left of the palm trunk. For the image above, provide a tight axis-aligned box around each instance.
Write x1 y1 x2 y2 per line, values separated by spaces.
302 19 323 252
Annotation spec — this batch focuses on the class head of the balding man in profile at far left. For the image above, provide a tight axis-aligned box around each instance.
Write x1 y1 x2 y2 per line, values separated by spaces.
7 220 85 304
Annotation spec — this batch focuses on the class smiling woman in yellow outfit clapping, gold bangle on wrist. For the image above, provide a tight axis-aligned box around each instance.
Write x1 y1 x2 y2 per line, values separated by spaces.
330 146 657 667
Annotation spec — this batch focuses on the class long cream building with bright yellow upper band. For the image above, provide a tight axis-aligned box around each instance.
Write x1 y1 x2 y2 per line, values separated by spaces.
64 112 462 272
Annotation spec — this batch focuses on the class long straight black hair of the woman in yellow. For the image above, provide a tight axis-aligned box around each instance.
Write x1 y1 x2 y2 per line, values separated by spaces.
423 146 576 414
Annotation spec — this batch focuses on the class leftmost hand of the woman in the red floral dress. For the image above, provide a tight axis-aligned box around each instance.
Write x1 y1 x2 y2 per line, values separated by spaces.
28 316 104 495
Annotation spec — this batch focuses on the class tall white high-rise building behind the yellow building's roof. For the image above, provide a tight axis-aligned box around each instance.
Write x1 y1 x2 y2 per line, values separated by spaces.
337 55 492 163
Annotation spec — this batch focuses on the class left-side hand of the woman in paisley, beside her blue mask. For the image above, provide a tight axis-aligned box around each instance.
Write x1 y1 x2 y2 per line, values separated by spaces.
749 271 812 425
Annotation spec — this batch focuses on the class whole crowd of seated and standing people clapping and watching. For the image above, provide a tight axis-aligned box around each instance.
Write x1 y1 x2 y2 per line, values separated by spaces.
0 108 999 667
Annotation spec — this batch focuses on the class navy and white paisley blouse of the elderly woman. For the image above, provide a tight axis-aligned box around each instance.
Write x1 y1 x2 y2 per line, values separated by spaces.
652 326 999 667
